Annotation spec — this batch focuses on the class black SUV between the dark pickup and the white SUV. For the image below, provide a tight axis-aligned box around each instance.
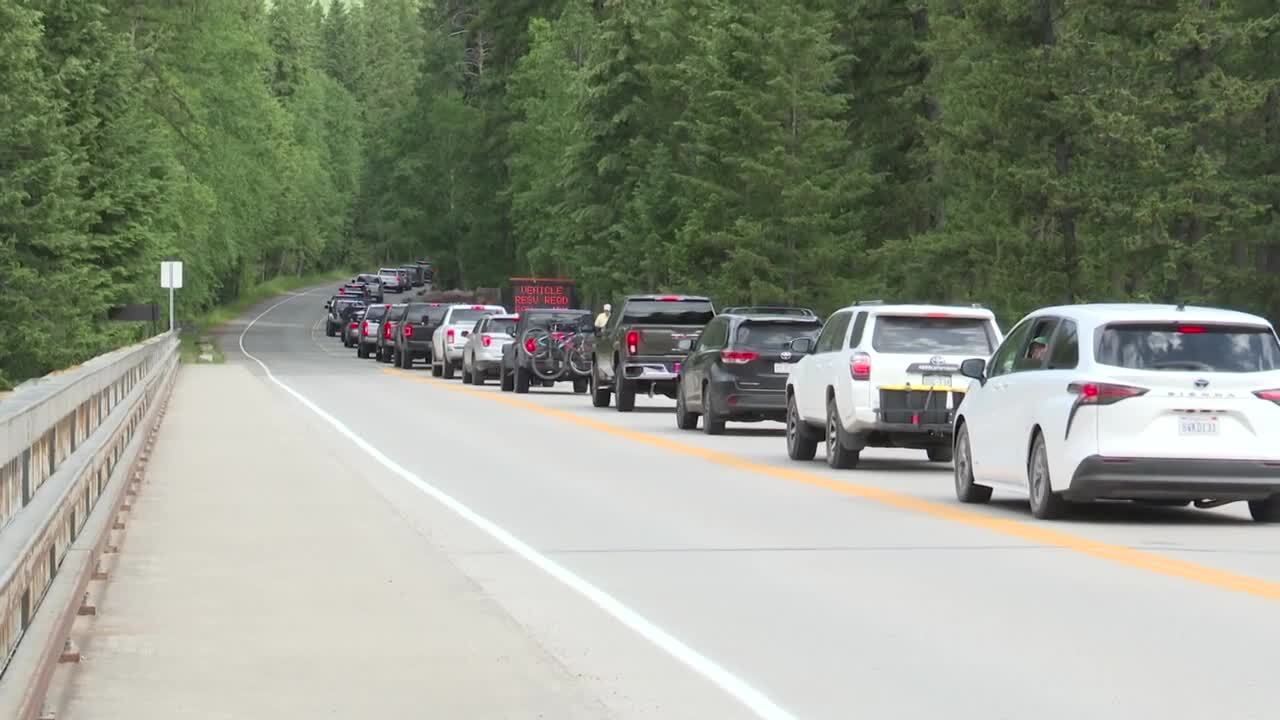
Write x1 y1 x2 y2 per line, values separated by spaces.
676 307 822 434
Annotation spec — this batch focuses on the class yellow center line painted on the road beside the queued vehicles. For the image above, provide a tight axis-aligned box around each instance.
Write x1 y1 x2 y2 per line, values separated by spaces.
383 368 1280 600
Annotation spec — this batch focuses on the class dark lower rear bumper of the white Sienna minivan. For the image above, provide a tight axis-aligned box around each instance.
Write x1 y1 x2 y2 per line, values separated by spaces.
1065 455 1280 501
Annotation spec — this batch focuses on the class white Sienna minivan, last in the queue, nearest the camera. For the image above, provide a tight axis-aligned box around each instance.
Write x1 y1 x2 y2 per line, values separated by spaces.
955 305 1280 523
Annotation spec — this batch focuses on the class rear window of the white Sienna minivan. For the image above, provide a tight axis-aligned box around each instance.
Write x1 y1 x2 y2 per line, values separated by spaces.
1096 323 1280 373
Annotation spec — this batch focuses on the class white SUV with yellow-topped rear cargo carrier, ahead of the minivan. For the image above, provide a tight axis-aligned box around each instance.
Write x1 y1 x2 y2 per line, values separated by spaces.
786 302 1001 468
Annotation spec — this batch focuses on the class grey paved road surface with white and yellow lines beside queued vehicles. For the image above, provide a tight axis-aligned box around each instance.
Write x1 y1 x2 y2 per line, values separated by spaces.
225 283 1280 720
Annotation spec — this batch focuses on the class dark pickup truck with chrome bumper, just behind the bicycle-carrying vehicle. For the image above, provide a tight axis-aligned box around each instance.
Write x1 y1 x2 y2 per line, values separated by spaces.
588 295 716 413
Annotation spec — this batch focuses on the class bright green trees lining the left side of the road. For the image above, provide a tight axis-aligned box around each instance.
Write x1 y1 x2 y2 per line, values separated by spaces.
0 0 370 382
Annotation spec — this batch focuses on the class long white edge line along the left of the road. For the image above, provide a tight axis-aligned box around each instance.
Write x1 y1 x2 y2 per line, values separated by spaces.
239 288 797 720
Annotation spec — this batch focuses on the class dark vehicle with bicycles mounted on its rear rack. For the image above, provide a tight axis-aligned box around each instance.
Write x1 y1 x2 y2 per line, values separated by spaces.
500 307 595 393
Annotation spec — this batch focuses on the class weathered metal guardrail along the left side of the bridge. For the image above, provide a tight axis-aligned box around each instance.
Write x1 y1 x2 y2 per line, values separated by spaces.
0 333 178 680
